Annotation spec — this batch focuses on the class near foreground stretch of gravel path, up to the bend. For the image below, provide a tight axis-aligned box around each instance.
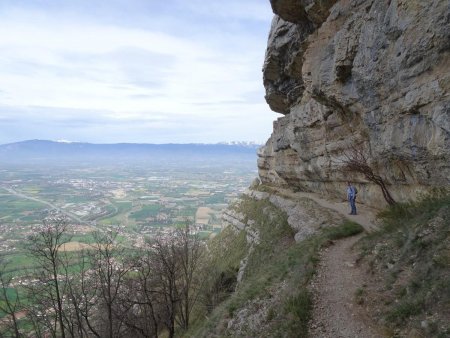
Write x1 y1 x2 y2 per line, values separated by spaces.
310 235 382 338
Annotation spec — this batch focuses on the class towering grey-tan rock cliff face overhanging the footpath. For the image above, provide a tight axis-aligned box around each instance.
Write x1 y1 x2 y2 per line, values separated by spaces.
258 0 450 206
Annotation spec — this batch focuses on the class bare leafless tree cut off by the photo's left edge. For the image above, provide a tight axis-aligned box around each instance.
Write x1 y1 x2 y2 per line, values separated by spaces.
0 260 22 338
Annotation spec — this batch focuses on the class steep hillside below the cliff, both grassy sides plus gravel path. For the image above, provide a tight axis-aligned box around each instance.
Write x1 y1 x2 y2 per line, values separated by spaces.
188 186 450 338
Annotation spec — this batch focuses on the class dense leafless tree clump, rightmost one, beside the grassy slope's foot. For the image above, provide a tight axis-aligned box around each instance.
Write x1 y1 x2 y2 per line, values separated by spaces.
121 223 203 337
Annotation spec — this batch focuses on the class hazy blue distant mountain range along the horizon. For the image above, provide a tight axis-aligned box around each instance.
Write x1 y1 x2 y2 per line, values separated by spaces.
0 140 260 164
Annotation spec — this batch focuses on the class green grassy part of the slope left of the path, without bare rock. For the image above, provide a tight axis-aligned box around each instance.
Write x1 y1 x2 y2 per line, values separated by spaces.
185 198 362 337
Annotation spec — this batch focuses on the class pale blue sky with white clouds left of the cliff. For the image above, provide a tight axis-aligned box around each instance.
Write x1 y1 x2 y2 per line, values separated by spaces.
0 0 278 144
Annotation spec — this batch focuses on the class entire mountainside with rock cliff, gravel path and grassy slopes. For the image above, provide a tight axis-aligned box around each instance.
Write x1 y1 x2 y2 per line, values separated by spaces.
187 0 450 337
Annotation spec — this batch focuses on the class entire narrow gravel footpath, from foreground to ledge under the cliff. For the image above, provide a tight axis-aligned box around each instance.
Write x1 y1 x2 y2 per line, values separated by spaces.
268 186 383 338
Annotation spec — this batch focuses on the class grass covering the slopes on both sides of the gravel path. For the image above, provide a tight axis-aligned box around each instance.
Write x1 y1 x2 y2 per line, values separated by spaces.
186 193 450 337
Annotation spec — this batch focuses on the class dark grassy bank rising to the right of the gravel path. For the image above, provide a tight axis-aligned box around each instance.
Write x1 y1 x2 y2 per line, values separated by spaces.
359 194 450 337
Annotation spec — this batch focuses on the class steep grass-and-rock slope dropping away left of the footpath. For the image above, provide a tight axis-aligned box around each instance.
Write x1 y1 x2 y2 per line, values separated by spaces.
185 191 363 337
